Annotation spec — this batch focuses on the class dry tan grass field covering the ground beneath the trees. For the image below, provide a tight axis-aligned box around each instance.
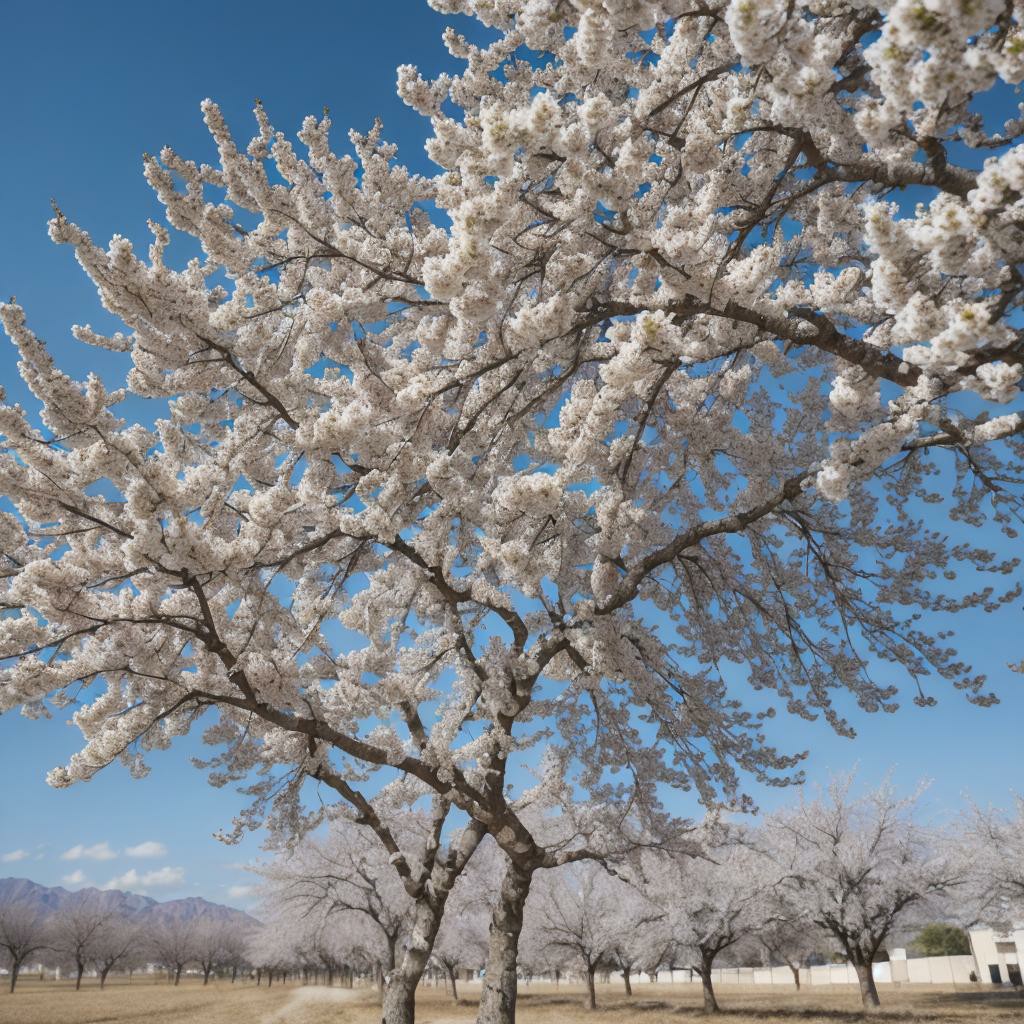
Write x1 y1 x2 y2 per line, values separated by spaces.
0 980 1024 1024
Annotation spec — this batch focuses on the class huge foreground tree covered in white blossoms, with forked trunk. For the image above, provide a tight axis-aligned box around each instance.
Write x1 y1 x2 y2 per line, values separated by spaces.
0 0 1024 1022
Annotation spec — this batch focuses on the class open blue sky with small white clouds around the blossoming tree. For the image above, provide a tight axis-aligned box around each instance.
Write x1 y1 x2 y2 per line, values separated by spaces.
0 0 1024 905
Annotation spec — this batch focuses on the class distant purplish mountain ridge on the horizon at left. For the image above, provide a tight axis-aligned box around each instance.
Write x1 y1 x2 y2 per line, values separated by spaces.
0 879 258 926
